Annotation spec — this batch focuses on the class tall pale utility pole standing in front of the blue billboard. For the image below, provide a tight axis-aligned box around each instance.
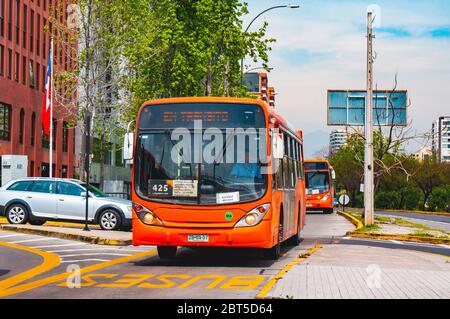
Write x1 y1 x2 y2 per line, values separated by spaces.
364 12 374 225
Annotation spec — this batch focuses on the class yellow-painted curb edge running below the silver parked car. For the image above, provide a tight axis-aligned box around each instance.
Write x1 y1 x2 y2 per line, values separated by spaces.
0 225 132 246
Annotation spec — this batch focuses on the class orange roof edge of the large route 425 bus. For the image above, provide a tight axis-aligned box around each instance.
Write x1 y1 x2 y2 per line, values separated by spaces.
139 96 301 139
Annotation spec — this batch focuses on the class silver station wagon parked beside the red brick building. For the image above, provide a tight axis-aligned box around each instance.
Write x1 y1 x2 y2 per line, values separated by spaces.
0 177 131 230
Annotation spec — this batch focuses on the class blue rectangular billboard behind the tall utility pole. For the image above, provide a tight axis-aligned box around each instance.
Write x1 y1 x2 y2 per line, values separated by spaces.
328 90 408 126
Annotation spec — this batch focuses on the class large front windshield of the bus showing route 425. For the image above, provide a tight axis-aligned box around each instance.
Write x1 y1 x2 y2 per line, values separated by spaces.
134 104 267 205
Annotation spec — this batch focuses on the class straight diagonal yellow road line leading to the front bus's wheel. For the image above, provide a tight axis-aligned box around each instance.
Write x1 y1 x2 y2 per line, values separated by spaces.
0 249 156 297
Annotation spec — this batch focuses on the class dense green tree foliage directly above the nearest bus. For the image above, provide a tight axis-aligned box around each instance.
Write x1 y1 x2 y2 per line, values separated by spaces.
114 0 273 118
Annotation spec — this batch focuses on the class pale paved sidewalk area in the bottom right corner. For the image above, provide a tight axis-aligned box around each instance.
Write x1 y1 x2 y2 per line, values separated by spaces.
267 245 450 299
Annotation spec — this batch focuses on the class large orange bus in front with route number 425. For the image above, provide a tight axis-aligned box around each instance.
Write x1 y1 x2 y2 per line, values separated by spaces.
132 97 306 259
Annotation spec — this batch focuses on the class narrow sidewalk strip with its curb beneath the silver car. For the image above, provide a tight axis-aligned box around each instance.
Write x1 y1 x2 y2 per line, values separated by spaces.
0 224 132 246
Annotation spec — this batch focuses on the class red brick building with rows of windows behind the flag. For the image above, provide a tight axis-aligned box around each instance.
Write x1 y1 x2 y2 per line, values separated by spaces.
0 0 76 181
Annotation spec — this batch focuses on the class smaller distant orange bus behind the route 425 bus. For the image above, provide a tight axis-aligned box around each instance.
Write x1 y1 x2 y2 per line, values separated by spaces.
305 159 334 214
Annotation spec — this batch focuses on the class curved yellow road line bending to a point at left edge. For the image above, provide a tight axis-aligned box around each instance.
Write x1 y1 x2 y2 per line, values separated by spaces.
0 242 61 296
